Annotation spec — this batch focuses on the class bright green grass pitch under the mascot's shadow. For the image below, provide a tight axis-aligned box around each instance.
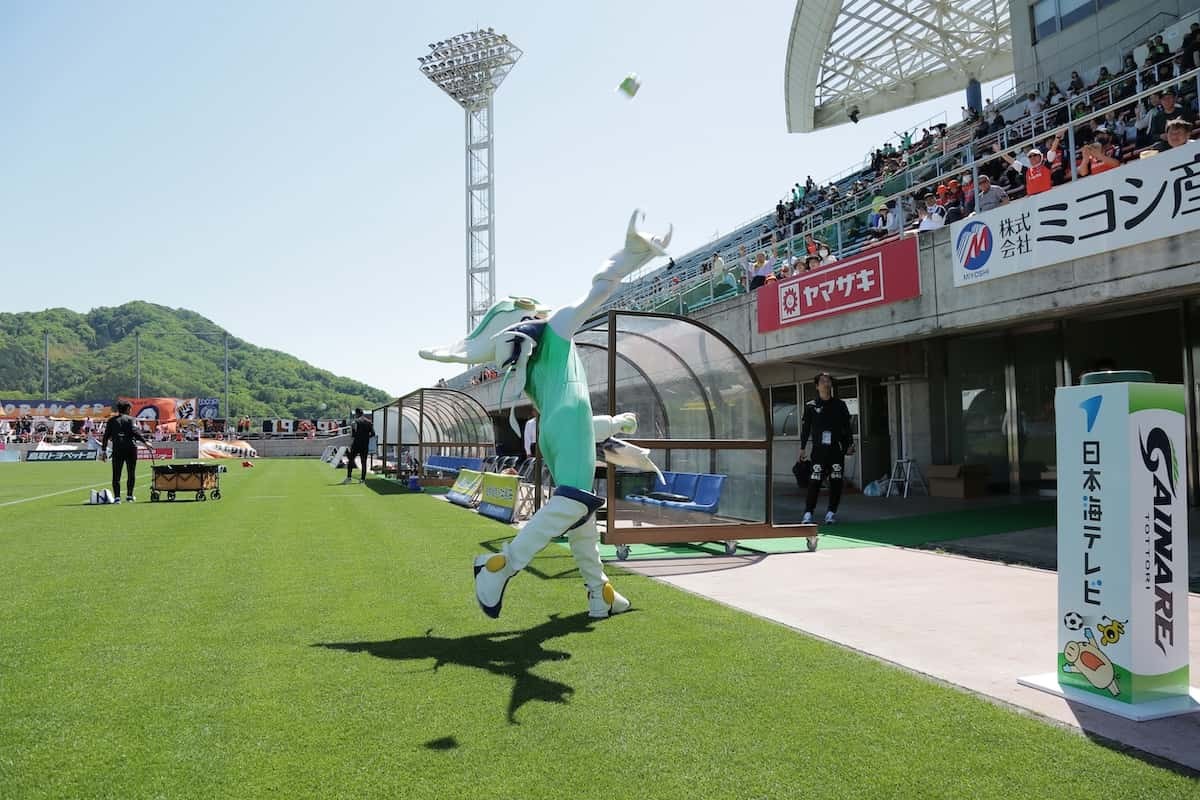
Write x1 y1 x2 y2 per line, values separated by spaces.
0 461 1200 800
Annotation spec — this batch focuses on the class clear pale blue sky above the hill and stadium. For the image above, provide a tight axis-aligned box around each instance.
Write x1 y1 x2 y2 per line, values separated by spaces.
0 0 1012 393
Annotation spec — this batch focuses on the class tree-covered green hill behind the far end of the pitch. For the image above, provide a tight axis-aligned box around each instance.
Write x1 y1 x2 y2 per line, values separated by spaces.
0 302 390 419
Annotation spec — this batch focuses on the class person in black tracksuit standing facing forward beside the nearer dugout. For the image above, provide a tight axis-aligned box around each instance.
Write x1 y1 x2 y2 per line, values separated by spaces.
800 372 854 524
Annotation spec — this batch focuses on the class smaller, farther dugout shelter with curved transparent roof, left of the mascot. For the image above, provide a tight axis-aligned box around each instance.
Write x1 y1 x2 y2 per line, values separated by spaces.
371 387 496 486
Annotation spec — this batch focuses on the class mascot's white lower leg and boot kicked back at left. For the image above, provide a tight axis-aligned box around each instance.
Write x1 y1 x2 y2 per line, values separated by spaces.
473 489 594 619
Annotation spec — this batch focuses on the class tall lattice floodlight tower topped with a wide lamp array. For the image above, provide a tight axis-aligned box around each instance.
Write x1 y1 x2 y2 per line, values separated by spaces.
418 28 521 333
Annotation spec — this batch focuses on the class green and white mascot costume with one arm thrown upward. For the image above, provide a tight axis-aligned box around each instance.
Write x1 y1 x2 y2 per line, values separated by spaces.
420 211 671 618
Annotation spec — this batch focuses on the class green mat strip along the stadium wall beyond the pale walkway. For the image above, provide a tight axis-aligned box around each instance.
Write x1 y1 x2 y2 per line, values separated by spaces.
585 500 1055 561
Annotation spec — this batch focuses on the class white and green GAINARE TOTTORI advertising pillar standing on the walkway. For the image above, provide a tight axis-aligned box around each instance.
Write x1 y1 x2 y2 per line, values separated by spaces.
1022 383 1200 720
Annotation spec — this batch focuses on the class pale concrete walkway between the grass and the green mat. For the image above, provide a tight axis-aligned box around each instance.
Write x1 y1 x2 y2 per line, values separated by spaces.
622 547 1200 770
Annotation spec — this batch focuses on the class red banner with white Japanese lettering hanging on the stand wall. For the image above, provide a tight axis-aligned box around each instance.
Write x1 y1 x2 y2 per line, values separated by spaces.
757 236 920 333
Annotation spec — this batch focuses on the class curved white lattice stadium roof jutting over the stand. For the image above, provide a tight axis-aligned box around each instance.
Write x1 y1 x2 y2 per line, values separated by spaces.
784 0 1013 133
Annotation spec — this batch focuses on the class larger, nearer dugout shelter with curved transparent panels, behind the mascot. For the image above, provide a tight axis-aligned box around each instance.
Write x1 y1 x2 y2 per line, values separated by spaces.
575 309 818 560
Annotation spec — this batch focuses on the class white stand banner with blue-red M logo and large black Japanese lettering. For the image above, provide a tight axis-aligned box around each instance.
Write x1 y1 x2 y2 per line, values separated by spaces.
950 142 1200 287
